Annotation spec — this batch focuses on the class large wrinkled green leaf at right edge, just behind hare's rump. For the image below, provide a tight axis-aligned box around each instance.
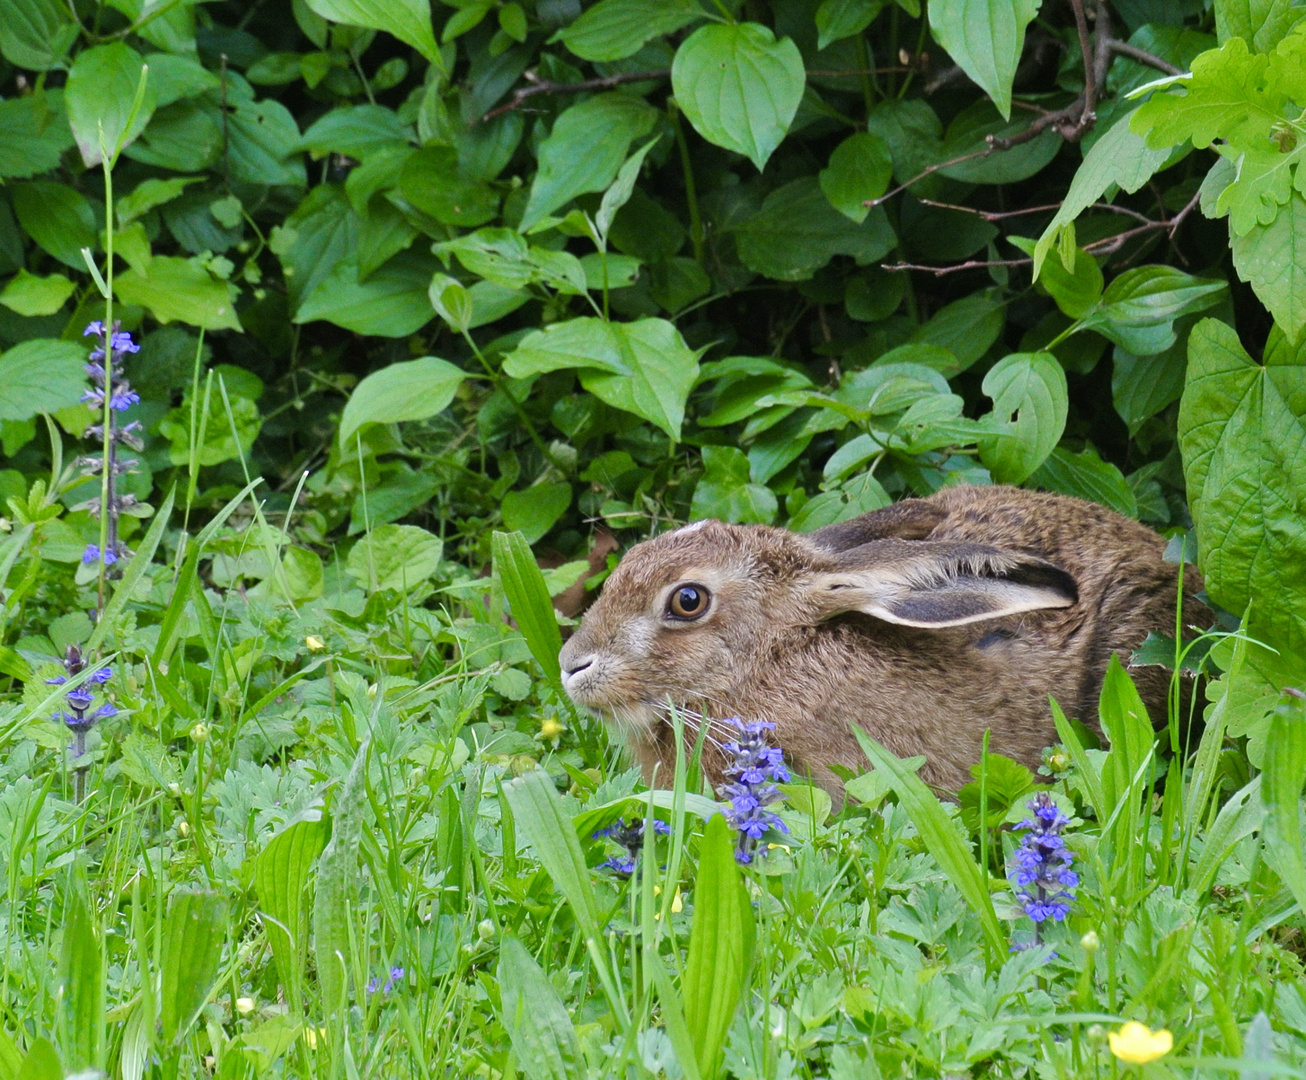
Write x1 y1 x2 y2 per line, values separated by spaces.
1179 319 1306 653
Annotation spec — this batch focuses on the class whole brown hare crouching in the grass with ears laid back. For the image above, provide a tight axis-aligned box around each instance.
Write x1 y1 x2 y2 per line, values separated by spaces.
562 487 1207 791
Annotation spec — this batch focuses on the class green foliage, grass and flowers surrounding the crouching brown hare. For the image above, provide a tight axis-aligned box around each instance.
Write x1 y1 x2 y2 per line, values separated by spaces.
0 0 1306 1080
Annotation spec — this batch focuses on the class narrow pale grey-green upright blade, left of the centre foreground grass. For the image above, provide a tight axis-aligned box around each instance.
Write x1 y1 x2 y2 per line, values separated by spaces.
313 739 371 1016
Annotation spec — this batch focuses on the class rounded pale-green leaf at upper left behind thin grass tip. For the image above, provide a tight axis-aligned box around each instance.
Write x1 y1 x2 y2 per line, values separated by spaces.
64 42 155 168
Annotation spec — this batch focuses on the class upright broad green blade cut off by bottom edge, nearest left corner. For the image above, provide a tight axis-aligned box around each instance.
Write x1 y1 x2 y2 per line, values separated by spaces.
56 889 106 1071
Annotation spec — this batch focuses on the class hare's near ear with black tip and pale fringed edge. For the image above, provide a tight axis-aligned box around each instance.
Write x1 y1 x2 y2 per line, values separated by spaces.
810 539 1079 628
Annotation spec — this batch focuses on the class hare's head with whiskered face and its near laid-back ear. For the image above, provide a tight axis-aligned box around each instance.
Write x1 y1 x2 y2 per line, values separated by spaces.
560 521 1077 734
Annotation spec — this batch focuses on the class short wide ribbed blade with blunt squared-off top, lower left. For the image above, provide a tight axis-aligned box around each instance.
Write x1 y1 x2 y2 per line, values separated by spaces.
159 891 227 1045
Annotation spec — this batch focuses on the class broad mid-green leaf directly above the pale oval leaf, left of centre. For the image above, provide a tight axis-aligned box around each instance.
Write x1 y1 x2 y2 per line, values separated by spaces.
295 251 435 337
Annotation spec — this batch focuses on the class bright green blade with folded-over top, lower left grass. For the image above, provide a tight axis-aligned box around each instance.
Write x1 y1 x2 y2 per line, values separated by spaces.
253 809 329 1012
